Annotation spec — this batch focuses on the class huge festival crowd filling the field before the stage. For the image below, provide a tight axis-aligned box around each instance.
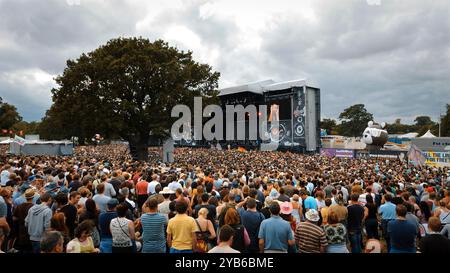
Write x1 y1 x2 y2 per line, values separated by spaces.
0 145 450 253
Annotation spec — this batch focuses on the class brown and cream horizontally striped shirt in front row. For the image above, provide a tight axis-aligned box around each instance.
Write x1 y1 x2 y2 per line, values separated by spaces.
295 222 328 253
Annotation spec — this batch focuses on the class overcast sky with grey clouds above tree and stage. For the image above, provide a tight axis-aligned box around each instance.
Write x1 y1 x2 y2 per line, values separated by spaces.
0 0 450 122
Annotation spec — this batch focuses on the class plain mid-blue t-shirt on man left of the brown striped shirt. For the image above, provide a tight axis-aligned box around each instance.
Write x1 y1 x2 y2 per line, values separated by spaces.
258 215 294 251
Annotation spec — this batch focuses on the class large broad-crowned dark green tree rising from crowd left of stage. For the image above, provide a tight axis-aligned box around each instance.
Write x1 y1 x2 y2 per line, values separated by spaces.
40 38 219 160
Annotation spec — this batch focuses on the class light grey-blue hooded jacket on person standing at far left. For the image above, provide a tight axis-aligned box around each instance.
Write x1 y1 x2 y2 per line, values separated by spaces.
25 204 52 241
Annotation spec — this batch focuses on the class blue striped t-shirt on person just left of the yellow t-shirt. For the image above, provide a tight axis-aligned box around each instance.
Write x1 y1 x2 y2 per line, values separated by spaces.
141 213 167 253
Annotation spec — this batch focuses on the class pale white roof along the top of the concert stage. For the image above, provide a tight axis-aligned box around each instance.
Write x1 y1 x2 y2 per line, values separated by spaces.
219 79 316 96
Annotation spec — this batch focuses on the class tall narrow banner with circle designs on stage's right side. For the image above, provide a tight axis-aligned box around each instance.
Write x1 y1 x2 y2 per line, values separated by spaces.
292 87 306 146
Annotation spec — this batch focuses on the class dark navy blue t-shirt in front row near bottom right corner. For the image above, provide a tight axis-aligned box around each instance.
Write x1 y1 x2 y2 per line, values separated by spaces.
388 220 417 250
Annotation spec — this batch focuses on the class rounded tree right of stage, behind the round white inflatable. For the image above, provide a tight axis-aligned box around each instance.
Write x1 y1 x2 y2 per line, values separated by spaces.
339 104 373 137
